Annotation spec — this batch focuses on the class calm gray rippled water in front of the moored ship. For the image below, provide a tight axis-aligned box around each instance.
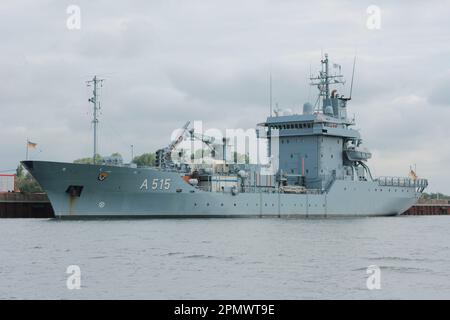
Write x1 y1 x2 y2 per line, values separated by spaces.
0 216 450 299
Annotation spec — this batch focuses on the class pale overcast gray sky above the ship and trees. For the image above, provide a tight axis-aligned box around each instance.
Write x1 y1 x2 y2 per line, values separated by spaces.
0 0 450 194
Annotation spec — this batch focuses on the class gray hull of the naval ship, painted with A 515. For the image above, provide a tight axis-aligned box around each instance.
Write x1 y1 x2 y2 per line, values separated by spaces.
23 161 420 218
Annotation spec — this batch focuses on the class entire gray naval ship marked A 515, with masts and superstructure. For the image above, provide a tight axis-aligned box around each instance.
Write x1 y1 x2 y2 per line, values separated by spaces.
22 55 428 217
